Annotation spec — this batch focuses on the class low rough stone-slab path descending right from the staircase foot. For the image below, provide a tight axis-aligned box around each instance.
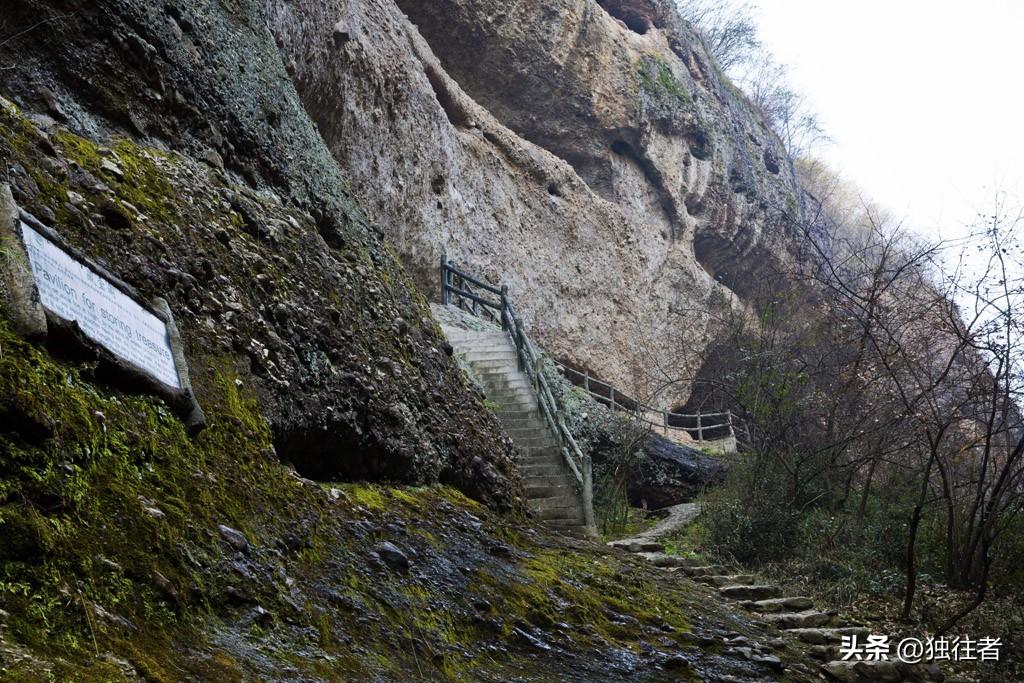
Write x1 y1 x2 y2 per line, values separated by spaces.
608 516 944 683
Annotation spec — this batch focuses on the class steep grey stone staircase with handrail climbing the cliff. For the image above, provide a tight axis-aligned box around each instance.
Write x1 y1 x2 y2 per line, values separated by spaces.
435 315 592 536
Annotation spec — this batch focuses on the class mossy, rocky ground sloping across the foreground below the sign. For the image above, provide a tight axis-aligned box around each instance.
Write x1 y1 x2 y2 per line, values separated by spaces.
0 313 831 681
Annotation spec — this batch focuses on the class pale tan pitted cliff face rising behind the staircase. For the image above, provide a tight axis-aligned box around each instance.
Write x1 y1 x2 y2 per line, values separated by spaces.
267 0 798 402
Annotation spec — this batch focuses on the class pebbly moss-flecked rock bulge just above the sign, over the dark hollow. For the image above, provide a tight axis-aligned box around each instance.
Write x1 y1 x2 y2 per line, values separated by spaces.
0 58 518 508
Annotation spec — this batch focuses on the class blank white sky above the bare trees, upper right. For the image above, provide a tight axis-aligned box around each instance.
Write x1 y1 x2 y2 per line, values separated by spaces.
755 0 1024 237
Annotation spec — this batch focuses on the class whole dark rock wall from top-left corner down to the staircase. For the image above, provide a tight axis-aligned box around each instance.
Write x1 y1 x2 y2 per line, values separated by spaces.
0 0 517 507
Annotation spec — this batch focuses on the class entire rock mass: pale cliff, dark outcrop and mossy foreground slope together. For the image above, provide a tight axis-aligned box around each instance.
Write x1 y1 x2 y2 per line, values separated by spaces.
0 0 831 681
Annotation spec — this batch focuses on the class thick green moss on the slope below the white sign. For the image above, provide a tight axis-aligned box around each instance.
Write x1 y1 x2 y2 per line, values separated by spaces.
0 321 294 680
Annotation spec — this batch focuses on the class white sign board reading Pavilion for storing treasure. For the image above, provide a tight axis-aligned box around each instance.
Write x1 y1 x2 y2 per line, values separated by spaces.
22 221 181 389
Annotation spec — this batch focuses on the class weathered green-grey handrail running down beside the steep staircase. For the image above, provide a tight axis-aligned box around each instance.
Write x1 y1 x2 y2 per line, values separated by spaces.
440 255 596 530
